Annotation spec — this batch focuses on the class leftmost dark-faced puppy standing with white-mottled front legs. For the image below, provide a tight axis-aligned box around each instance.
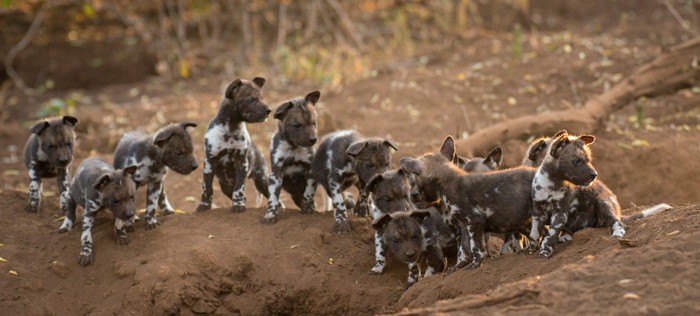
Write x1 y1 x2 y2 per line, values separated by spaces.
24 116 78 213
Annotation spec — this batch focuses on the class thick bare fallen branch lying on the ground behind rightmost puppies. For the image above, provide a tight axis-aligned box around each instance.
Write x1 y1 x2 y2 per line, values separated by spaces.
457 37 700 156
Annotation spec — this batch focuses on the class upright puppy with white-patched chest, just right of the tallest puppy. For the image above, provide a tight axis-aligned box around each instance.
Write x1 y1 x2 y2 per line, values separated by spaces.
262 91 321 224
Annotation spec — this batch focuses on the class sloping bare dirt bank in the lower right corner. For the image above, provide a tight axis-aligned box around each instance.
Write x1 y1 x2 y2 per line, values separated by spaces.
399 205 700 315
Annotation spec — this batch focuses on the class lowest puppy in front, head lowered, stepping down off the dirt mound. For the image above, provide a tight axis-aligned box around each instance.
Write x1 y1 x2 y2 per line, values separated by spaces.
372 208 450 288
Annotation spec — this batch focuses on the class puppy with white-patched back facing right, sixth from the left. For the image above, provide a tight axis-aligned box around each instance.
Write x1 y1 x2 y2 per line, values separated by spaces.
311 130 398 234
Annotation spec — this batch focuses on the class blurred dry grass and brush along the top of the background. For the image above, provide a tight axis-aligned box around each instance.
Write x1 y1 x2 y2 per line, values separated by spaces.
0 0 533 93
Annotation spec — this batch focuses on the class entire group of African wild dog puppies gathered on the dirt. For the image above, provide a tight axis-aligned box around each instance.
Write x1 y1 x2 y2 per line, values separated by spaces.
24 77 668 286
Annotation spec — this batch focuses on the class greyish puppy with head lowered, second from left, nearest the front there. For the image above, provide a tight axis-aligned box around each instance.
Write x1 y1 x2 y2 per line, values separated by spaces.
58 158 137 266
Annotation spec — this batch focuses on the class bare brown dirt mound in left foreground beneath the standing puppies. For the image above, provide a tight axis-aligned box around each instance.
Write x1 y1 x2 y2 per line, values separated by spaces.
0 190 406 315
